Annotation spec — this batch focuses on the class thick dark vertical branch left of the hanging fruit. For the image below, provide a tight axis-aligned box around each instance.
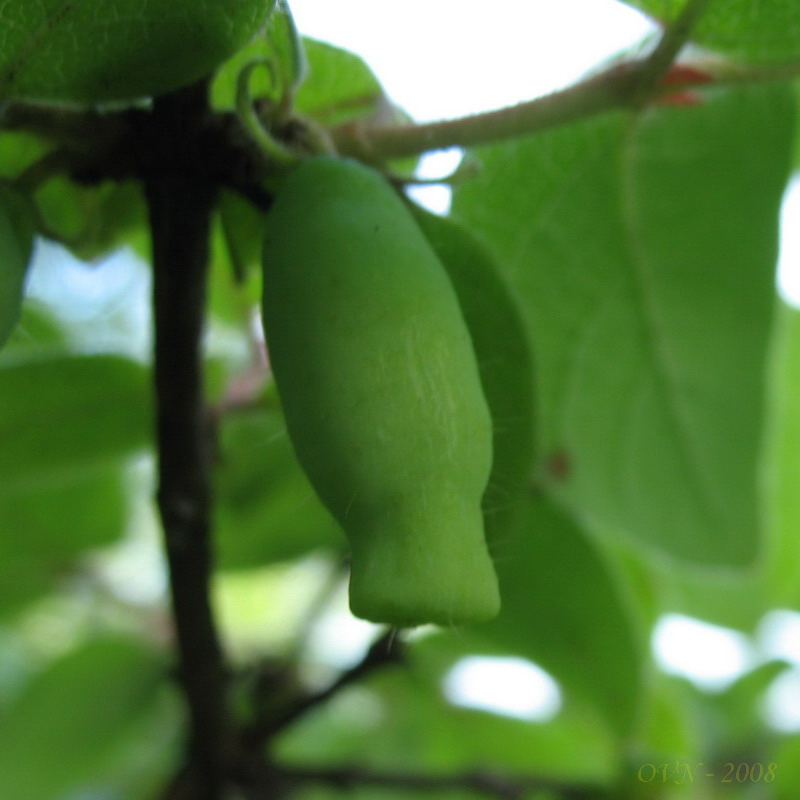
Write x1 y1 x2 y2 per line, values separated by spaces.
141 81 227 800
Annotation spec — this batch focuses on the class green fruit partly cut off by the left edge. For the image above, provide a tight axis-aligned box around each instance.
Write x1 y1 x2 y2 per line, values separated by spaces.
0 187 33 347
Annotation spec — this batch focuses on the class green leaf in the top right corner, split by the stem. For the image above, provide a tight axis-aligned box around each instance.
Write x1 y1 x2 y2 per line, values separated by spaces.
626 0 800 62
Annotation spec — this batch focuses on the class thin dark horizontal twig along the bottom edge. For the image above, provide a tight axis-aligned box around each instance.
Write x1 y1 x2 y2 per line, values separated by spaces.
264 764 605 800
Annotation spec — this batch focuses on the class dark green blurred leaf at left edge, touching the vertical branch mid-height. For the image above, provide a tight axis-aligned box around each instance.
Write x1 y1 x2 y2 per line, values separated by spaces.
0 355 151 495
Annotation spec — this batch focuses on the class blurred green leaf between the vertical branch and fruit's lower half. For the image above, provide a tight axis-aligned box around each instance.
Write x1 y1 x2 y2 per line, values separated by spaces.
215 400 344 569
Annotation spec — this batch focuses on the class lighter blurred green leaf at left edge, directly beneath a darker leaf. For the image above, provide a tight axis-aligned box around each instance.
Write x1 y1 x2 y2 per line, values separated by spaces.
0 464 127 617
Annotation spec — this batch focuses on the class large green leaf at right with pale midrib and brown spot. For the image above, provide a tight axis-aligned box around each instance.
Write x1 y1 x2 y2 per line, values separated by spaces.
454 85 793 564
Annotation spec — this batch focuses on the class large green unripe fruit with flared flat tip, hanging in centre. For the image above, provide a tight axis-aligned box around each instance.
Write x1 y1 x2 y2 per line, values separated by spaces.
264 158 500 625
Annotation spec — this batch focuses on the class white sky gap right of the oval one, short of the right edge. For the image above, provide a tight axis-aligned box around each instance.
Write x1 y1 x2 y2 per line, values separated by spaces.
652 614 754 691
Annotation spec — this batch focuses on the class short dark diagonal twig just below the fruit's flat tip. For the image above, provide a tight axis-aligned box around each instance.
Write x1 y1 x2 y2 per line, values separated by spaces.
243 629 405 750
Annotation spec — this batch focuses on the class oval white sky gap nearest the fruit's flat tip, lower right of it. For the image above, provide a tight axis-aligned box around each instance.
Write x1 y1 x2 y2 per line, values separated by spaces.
444 656 561 722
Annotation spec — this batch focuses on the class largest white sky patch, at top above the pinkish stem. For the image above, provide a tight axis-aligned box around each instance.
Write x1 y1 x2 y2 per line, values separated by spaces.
292 0 653 120
